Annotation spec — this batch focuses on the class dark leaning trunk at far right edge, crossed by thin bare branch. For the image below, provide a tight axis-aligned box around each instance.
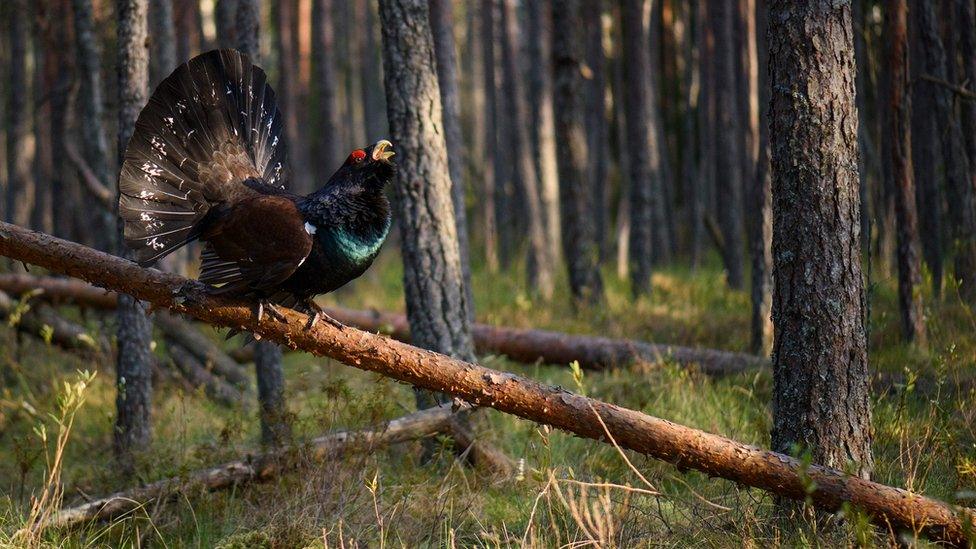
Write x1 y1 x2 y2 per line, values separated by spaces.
911 0 976 303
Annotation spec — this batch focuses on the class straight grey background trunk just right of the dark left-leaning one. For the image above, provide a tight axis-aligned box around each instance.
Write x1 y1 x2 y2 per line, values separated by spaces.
620 0 662 296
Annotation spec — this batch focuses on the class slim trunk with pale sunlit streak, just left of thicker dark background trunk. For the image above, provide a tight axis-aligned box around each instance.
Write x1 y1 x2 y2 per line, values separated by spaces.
526 1 562 266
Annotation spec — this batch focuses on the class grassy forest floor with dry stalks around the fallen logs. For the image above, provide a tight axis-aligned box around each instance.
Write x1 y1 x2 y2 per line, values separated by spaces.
0 250 976 548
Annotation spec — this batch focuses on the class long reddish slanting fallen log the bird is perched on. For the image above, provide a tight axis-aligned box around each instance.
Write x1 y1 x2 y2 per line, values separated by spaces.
0 222 976 547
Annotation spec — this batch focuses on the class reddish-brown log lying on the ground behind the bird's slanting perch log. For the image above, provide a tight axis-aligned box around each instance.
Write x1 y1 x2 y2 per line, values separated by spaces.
0 275 769 375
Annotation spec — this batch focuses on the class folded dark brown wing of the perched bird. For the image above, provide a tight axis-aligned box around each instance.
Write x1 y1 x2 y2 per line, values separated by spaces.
200 195 312 293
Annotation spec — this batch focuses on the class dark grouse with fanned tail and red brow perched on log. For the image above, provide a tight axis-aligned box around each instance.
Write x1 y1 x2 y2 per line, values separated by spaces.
118 49 396 327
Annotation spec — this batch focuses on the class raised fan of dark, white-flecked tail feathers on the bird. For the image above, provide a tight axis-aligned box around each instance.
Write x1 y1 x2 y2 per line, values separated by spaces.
119 50 286 264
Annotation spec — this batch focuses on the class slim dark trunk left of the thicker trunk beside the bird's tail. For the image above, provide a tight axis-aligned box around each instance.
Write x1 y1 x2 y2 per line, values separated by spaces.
72 0 115 251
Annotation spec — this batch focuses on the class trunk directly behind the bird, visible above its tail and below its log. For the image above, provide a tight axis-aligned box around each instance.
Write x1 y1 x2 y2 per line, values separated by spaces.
234 0 290 447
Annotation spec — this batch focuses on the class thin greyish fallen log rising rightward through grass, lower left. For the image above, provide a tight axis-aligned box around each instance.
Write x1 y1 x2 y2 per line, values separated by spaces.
49 405 466 529
